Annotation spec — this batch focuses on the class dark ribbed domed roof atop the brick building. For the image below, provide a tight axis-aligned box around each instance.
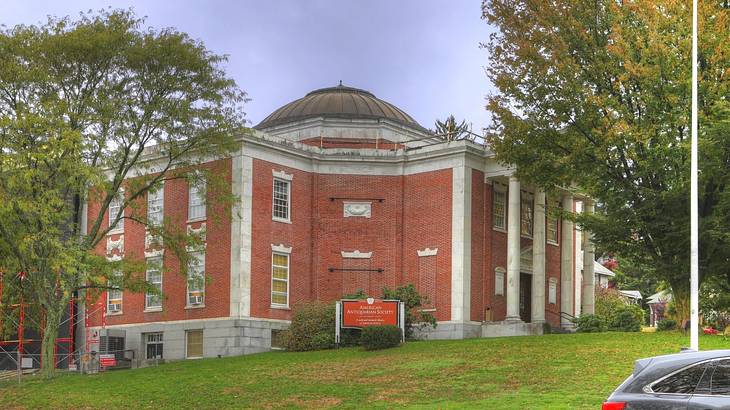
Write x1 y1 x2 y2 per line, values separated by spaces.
254 82 425 131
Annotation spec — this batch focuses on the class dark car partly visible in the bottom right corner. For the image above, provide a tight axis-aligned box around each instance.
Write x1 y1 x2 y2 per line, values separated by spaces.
602 350 730 410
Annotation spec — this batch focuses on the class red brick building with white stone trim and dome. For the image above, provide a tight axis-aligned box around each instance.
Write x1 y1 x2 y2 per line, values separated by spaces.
88 85 593 359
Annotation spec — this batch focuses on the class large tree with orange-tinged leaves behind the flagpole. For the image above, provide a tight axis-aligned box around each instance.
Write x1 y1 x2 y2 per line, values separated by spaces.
483 0 730 324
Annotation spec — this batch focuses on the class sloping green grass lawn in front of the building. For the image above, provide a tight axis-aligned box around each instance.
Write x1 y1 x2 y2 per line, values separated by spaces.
0 332 730 409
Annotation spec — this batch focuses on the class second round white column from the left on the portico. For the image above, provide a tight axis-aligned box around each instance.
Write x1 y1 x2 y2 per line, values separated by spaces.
532 188 546 323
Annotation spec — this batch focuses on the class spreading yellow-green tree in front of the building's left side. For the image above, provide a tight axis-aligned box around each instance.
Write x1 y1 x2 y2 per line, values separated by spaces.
0 10 245 377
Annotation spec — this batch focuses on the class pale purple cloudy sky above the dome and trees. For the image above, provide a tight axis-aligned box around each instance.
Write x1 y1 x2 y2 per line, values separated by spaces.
0 0 493 132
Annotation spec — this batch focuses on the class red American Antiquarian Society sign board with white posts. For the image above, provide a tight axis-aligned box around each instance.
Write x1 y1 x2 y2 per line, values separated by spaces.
335 298 406 346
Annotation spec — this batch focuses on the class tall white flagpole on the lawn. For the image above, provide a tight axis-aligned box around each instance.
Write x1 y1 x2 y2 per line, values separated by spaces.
689 0 700 351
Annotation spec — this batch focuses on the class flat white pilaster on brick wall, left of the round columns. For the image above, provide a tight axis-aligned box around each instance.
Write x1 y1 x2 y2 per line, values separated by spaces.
451 165 471 321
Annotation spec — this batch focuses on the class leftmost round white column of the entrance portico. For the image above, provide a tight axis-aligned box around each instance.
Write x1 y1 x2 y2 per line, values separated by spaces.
505 176 521 322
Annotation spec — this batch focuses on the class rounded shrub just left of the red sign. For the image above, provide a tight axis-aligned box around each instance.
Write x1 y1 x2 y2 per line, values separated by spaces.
286 302 335 352
